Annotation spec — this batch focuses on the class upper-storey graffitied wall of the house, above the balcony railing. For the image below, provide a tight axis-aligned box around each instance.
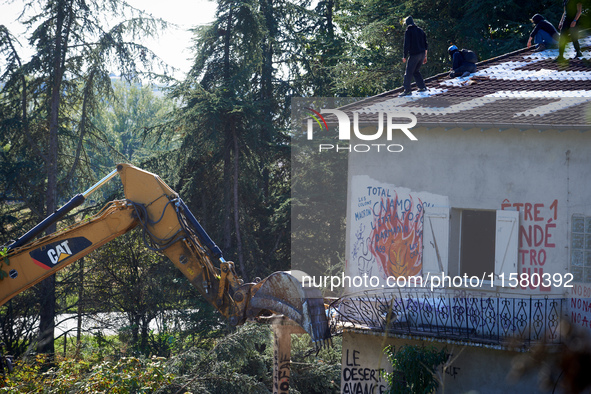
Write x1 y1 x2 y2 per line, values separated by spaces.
346 128 591 295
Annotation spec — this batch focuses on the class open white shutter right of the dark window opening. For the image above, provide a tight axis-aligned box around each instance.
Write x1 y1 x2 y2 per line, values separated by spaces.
495 210 519 283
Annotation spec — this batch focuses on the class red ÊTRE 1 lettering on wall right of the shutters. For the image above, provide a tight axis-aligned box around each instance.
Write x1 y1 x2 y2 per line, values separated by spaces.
501 199 558 291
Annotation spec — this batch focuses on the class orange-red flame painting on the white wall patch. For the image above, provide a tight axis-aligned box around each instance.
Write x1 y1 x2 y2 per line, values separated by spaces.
370 195 424 277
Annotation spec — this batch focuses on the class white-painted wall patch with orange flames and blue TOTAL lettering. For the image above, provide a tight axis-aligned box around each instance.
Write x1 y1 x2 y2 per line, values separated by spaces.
348 175 447 279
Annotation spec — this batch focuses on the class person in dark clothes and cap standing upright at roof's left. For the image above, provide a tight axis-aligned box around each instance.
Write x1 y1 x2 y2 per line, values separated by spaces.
399 16 428 97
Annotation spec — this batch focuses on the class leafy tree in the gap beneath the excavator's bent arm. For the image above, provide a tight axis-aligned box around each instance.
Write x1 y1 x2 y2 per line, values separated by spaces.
75 231 222 357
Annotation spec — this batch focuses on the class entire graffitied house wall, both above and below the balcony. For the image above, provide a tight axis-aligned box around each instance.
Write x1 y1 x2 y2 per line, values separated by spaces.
341 128 591 393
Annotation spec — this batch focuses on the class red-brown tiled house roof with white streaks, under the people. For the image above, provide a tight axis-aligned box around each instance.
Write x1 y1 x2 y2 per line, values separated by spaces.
341 37 591 130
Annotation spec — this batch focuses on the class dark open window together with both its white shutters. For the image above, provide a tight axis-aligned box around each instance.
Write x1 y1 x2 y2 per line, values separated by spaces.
423 207 519 278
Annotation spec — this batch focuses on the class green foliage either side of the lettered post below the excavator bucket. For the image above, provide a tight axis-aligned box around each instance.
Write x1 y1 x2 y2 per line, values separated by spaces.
169 323 341 394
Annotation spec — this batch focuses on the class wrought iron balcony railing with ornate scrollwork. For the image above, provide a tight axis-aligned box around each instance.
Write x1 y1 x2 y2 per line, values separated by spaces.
329 289 566 345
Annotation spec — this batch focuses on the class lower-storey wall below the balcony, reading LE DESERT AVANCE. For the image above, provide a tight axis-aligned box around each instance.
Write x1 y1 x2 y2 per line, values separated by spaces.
341 332 545 394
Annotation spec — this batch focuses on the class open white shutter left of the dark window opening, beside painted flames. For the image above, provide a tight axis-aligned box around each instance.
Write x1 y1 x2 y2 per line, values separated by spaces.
423 207 449 278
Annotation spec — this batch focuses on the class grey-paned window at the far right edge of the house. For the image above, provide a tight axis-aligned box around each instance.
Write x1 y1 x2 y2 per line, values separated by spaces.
570 215 591 283
